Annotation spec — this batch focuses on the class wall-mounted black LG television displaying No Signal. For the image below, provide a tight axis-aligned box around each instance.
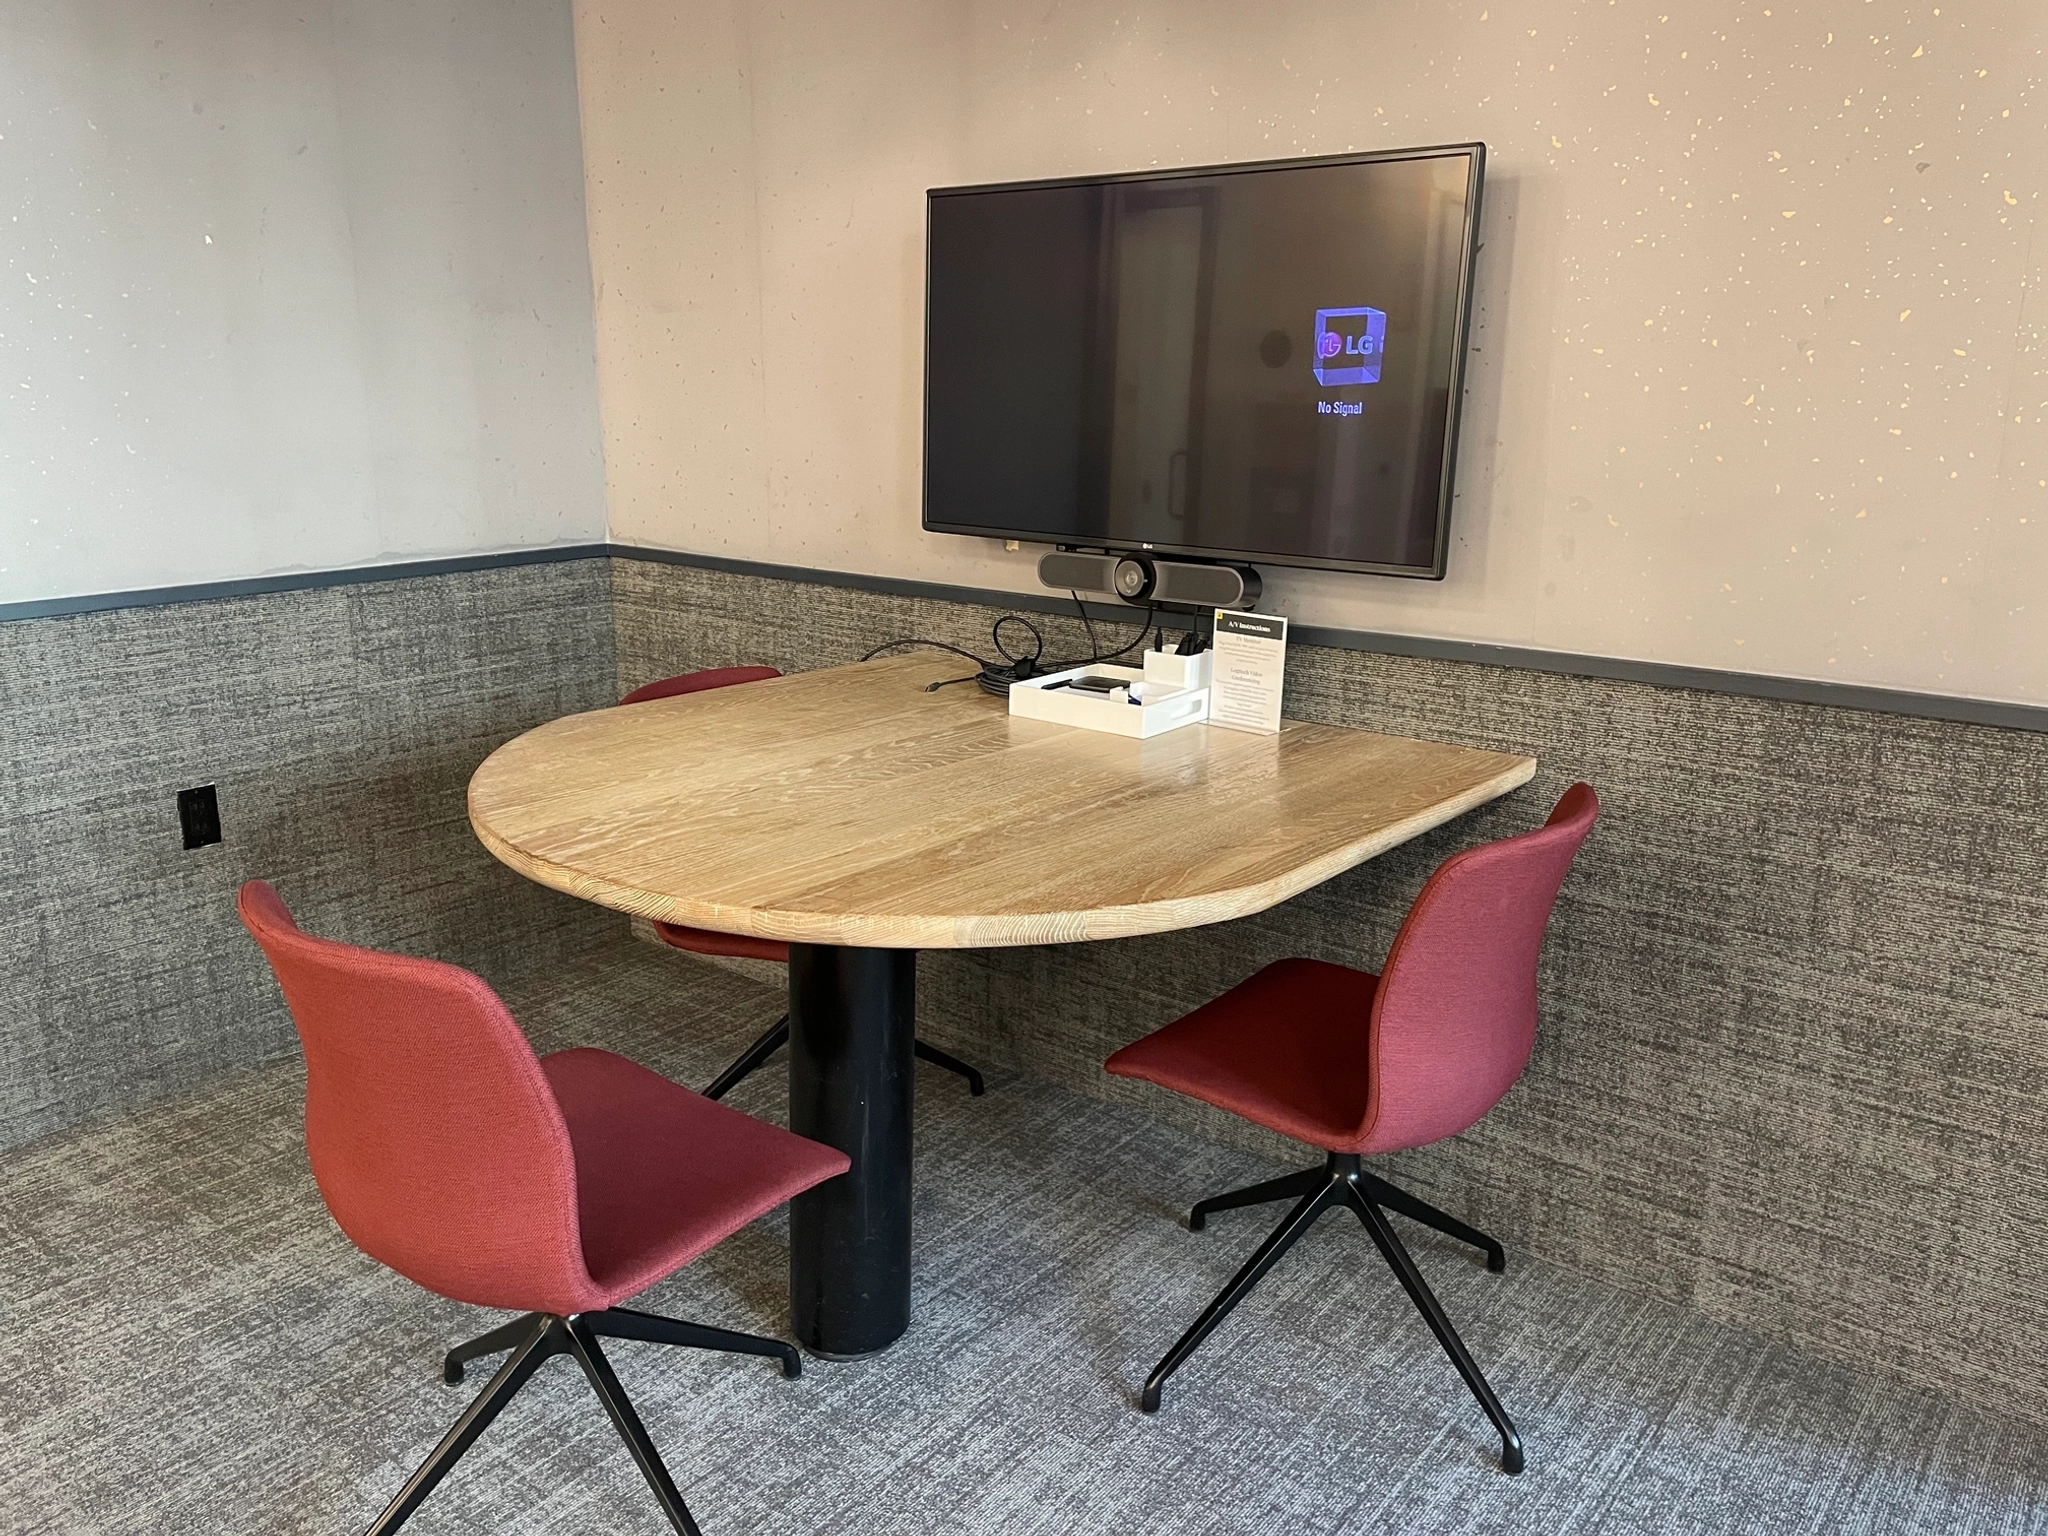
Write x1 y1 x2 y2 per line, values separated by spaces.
924 143 1485 578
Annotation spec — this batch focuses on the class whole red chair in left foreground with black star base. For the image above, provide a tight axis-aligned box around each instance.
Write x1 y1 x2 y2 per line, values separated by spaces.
238 881 848 1536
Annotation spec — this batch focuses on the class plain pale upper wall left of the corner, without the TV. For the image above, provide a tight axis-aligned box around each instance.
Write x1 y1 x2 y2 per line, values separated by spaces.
0 0 604 606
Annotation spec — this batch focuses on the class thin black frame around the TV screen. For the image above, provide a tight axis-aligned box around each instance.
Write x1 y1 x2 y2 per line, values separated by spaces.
918 141 1487 582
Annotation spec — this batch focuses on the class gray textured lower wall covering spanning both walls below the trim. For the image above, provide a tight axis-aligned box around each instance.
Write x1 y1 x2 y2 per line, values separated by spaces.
0 559 2048 1419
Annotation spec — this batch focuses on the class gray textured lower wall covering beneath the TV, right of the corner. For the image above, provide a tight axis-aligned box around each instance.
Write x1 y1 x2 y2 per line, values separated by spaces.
614 559 2048 1419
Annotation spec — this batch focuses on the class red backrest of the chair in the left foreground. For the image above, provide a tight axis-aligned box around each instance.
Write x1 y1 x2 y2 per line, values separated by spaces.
236 881 596 1313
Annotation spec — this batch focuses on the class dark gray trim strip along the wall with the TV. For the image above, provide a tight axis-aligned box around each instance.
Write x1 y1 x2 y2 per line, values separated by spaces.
612 545 2048 731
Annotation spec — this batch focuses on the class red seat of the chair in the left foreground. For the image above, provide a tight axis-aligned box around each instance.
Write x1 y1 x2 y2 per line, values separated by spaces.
541 1049 850 1307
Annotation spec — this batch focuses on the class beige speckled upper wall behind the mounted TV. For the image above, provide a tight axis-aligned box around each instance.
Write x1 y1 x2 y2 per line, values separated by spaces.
575 0 2048 702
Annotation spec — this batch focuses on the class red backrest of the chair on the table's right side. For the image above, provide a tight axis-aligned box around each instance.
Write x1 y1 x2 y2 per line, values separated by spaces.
1362 784 1599 1151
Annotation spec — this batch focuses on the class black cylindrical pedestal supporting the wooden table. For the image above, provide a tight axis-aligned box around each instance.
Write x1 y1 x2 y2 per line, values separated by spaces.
788 944 918 1358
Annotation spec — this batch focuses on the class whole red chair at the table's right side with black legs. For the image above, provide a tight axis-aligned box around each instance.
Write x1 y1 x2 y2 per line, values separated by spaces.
1108 784 1599 1473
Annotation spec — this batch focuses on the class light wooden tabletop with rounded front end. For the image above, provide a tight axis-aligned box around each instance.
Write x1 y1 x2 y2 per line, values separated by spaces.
469 655 1536 948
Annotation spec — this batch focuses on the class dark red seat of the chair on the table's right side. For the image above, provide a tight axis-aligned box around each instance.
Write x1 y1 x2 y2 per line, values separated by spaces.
1104 961 1380 1151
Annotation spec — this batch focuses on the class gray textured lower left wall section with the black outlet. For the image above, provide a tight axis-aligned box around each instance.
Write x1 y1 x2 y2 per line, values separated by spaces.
0 561 614 1145
